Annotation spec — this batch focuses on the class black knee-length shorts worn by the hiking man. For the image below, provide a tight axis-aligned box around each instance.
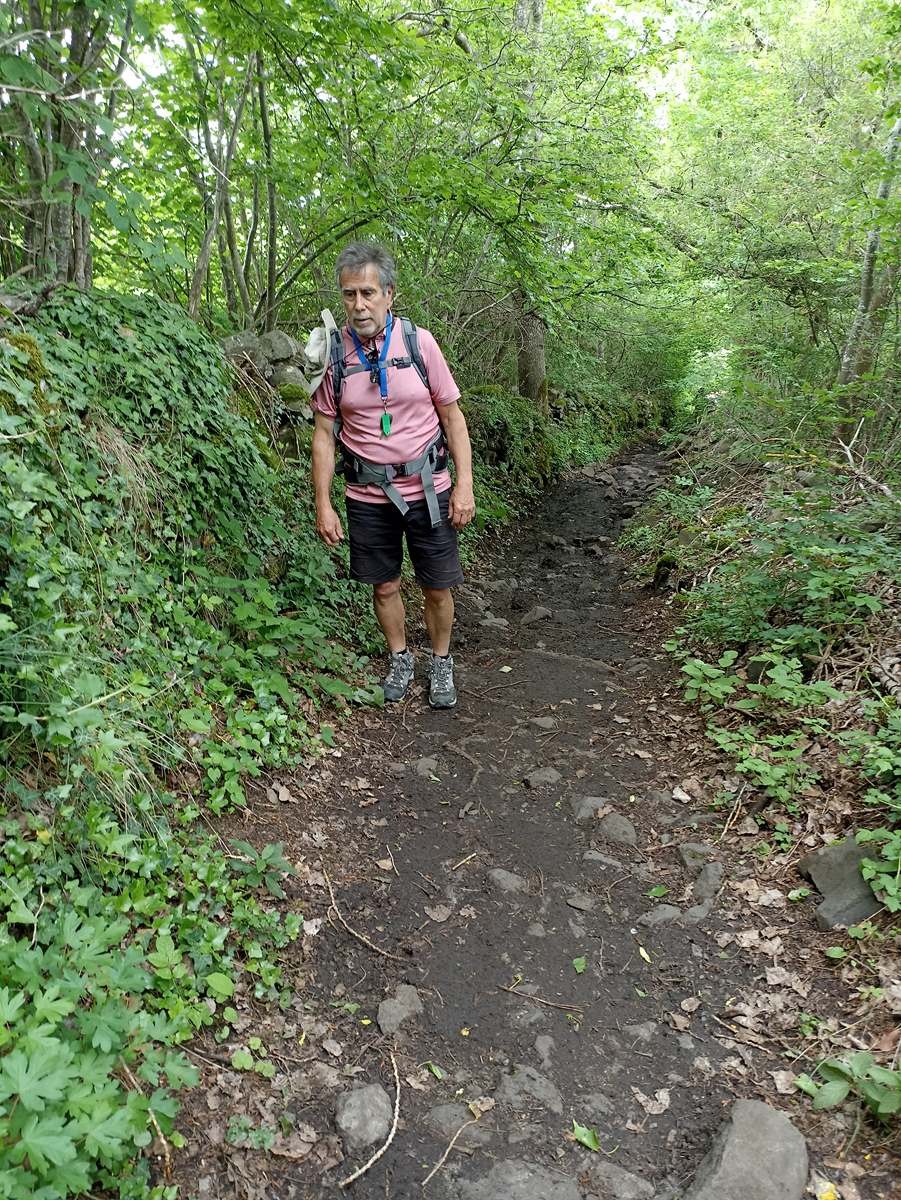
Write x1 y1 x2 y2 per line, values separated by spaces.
347 490 463 588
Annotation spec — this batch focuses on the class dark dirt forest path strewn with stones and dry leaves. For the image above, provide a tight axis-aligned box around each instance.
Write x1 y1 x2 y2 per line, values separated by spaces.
172 450 897 1200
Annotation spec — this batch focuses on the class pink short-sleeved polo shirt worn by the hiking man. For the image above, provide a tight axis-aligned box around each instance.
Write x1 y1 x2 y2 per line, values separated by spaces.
312 319 459 504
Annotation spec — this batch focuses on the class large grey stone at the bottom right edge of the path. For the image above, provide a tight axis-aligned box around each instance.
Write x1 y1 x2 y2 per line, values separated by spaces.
684 1100 807 1200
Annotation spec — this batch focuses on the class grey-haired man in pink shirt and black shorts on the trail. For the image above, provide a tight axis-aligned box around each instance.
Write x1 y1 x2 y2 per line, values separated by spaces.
313 242 475 708
